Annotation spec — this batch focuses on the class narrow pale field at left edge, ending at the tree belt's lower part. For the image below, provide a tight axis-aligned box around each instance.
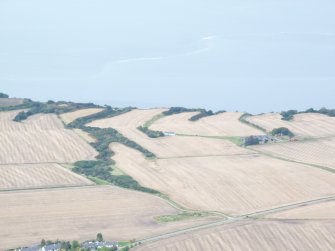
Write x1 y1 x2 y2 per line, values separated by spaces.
0 164 94 190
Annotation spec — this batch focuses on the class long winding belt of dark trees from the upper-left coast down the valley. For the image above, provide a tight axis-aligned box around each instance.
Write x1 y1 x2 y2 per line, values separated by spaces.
9 98 158 194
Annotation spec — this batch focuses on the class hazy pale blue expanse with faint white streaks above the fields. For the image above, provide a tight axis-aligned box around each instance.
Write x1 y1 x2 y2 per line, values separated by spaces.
0 0 335 113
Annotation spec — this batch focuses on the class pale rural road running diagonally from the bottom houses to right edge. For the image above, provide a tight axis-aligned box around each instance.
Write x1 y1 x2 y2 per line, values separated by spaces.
137 195 335 244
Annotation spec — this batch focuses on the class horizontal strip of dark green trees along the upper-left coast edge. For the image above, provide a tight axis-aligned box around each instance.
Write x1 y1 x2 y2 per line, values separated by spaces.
14 100 100 122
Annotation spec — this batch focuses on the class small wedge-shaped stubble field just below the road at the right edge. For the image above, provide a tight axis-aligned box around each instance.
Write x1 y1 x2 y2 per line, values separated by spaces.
267 201 335 219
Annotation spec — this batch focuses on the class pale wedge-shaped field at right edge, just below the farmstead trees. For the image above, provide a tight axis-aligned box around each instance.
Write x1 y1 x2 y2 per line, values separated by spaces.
252 138 335 169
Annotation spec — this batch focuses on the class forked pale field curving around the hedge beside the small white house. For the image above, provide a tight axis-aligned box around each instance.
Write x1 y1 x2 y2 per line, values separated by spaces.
89 109 250 158
